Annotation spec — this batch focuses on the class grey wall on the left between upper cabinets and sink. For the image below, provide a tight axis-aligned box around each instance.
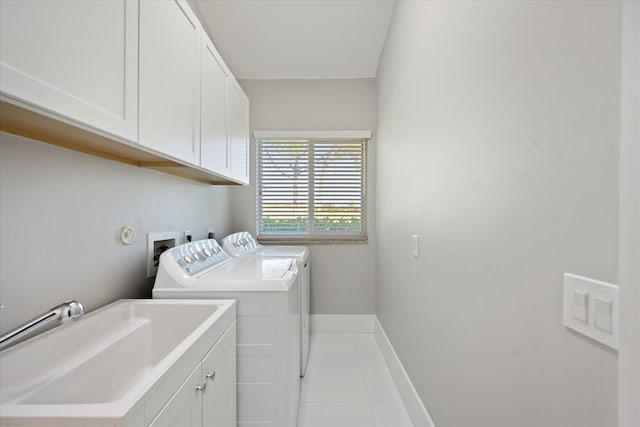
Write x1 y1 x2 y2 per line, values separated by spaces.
0 133 230 332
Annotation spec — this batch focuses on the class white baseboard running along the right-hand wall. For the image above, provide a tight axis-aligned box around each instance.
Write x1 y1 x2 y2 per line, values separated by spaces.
374 317 435 427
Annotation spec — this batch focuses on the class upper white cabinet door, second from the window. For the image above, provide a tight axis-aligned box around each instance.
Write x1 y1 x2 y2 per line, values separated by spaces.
200 36 229 175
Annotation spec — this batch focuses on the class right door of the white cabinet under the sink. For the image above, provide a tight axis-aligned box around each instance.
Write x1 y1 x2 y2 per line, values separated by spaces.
202 323 236 427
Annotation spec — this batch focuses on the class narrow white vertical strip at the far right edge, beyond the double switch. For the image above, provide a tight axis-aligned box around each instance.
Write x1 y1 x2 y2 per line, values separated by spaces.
618 1 640 427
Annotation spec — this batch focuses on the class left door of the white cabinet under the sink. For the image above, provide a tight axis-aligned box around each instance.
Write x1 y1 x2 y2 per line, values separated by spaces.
149 365 203 427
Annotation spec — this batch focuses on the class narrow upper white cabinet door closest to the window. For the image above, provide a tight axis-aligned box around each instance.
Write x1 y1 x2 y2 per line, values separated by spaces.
229 80 249 184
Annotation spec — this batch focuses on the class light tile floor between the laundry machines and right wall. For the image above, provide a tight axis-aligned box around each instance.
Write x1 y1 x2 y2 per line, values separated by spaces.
298 334 412 427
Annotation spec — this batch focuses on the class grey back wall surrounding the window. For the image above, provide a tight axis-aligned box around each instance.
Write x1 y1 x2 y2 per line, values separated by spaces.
231 79 376 314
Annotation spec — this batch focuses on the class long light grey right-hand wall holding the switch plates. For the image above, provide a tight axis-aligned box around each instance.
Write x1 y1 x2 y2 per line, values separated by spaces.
376 1 621 427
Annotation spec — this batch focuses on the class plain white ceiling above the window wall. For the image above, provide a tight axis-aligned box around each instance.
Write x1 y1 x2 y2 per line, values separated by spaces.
196 0 393 79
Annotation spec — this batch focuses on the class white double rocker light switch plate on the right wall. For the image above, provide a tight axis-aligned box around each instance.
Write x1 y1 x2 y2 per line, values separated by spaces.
562 273 619 350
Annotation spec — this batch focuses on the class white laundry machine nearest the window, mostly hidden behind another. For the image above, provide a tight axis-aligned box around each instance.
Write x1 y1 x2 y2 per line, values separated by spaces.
222 231 311 377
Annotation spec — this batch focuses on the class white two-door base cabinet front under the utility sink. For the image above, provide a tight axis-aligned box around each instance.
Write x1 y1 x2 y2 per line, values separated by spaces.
149 322 236 427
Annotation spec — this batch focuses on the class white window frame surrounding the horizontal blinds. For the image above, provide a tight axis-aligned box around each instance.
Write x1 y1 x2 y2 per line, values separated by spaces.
254 131 371 244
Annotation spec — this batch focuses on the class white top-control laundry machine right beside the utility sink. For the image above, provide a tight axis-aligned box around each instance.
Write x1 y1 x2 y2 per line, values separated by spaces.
153 240 300 427
